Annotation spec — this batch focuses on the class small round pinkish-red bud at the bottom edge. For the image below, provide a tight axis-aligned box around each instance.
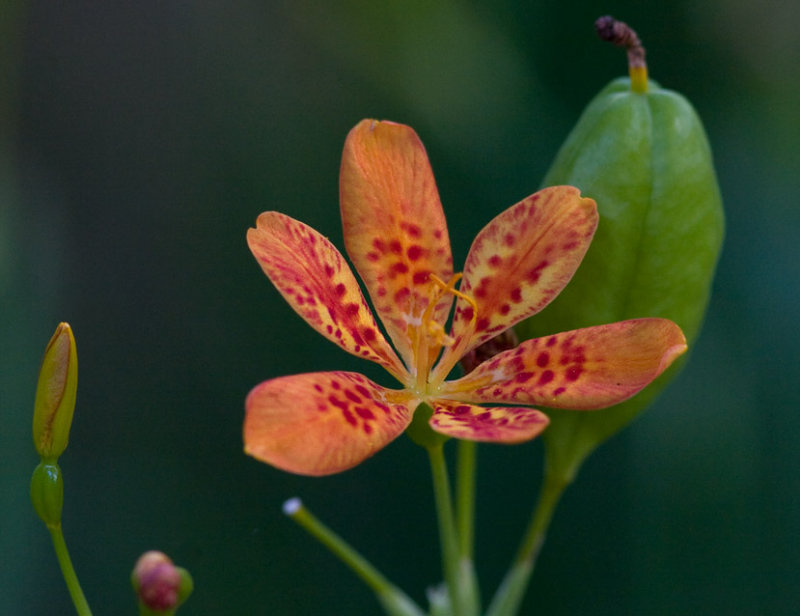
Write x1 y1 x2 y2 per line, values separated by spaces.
131 550 194 615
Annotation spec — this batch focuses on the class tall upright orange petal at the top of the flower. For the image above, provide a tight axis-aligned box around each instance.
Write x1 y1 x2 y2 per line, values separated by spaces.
339 120 453 366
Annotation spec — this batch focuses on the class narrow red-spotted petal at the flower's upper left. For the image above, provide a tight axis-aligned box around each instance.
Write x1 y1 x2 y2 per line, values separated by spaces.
247 212 406 381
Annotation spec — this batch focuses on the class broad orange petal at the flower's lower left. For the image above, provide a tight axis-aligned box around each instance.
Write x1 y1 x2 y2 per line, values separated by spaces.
244 372 416 475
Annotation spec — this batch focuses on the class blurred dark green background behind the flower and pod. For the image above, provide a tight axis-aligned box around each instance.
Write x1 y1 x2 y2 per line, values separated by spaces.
0 0 800 616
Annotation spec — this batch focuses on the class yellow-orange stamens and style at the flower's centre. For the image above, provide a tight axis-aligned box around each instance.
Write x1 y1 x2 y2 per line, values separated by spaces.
414 274 477 394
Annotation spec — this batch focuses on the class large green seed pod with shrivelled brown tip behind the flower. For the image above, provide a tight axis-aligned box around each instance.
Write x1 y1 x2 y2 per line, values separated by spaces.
517 18 724 479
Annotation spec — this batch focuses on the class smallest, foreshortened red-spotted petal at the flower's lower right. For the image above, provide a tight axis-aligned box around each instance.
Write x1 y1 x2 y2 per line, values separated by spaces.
430 400 549 444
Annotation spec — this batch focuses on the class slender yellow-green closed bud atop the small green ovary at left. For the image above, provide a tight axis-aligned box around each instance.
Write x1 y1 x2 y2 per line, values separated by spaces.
33 323 78 461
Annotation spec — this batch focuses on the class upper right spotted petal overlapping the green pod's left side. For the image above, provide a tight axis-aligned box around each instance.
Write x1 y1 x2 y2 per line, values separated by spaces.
446 186 597 352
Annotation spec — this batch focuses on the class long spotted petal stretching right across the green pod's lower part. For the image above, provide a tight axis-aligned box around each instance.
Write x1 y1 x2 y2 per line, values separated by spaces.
441 319 687 410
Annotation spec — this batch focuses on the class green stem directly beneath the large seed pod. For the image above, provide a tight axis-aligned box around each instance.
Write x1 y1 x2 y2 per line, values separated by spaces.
486 471 570 616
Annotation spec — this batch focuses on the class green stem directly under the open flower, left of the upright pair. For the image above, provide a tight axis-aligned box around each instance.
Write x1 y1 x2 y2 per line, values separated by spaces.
427 443 480 616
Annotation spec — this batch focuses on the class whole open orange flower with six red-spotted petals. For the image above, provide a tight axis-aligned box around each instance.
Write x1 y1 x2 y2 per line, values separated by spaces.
244 120 686 475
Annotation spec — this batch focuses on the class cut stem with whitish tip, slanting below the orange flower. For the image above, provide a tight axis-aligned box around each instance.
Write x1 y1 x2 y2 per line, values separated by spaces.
283 498 424 616
